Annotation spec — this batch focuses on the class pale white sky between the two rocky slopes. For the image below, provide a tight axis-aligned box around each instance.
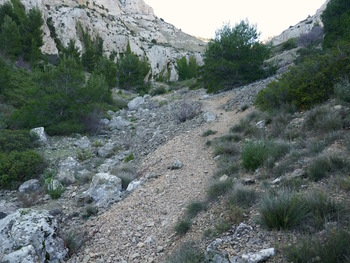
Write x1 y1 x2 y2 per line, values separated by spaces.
144 0 326 40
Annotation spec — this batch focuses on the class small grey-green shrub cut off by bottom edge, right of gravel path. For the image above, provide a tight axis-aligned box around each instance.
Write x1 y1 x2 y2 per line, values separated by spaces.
166 242 207 263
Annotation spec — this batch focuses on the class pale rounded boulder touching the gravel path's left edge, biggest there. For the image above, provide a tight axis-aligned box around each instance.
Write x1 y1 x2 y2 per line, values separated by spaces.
85 173 122 207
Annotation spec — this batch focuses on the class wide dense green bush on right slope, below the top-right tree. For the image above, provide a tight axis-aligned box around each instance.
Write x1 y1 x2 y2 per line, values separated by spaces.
255 45 350 110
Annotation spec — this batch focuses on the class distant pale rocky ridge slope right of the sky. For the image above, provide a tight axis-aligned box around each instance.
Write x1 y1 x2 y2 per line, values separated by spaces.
272 0 330 45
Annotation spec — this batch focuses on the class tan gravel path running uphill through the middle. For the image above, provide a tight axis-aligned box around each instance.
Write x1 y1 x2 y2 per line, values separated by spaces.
71 93 252 263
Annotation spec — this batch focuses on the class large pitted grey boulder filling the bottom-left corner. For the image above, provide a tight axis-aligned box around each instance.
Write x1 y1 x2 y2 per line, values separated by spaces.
0 209 67 262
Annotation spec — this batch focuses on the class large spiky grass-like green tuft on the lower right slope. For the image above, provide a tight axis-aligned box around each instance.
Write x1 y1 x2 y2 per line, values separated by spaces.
259 190 309 230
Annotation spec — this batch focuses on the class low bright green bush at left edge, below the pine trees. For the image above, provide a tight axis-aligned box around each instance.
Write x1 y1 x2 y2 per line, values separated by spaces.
0 150 45 189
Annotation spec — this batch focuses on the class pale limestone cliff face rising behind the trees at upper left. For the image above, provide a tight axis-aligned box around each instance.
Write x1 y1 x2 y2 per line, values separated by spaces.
0 0 205 80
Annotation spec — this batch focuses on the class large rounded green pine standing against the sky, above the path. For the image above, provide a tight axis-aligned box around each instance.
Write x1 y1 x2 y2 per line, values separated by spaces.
200 21 275 92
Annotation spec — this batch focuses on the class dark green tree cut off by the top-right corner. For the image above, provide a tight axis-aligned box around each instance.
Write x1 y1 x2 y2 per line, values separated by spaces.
322 0 350 48
